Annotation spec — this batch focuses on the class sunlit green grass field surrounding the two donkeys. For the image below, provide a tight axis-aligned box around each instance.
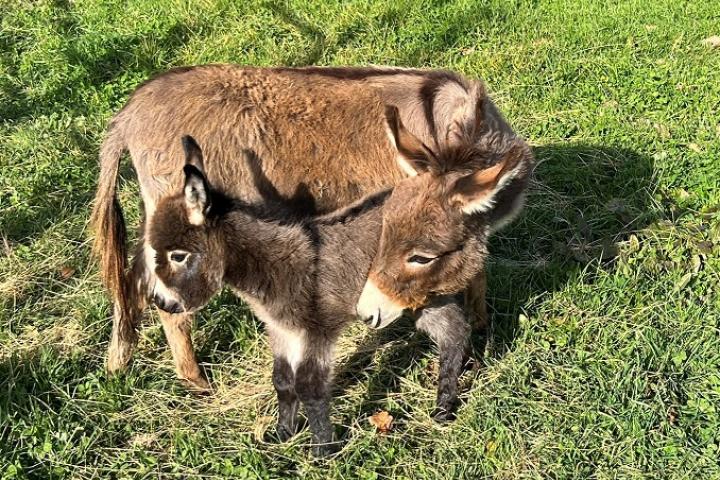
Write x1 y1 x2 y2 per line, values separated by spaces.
0 0 720 479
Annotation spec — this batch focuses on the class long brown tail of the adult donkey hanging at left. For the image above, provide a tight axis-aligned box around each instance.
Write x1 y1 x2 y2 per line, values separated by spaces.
90 124 131 319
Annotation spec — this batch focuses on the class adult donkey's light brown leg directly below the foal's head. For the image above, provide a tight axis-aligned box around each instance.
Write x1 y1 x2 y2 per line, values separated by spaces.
158 309 211 393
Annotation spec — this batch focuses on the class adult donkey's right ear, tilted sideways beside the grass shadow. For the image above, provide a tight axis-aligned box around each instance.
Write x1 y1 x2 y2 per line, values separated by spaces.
452 142 529 214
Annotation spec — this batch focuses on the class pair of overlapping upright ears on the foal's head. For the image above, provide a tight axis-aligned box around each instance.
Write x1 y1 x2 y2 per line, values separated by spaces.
183 135 211 225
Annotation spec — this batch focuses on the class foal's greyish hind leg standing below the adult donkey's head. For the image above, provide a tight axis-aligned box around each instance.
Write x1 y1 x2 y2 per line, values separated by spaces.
415 297 470 422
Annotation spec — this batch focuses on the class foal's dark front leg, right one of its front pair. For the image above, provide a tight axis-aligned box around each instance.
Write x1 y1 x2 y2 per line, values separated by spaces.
295 339 339 457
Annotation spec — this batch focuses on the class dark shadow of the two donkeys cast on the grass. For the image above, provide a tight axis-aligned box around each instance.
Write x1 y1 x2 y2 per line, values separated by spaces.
336 143 658 421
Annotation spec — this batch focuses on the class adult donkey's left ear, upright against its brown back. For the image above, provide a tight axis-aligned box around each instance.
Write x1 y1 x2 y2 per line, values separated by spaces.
385 105 437 177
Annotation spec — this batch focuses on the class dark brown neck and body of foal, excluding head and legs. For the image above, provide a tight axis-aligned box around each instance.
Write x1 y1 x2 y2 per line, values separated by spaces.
219 190 389 319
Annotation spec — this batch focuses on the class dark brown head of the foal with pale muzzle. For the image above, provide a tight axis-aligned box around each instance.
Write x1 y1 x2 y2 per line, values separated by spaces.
145 136 225 313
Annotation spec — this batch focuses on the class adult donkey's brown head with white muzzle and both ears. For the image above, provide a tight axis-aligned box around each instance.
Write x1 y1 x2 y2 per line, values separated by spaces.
357 107 532 328
